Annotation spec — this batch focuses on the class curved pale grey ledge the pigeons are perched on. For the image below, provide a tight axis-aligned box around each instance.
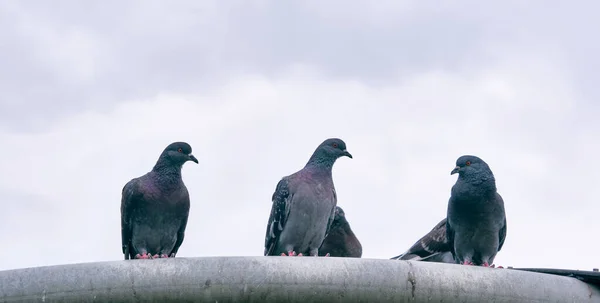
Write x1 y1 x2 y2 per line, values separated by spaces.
0 257 600 303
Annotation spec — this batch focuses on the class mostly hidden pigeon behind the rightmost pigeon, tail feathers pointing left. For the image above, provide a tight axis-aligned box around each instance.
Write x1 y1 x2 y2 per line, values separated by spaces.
391 218 454 263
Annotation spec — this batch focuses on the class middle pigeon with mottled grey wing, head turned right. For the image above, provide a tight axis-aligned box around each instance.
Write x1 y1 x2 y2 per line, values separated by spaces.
264 138 352 256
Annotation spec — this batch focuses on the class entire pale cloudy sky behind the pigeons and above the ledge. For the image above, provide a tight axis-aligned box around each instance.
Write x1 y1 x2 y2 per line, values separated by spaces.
0 0 600 270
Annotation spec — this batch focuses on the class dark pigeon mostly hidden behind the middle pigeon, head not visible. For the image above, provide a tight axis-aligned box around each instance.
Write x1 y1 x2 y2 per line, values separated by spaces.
319 206 362 258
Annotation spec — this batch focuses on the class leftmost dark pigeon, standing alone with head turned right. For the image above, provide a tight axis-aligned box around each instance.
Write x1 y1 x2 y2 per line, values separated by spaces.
121 142 198 260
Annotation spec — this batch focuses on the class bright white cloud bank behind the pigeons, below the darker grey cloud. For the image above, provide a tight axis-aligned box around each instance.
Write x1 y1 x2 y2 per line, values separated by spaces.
0 51 600 269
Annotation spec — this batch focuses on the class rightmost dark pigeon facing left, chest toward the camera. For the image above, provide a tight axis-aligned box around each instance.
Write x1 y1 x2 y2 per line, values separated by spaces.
446 155 506 267
